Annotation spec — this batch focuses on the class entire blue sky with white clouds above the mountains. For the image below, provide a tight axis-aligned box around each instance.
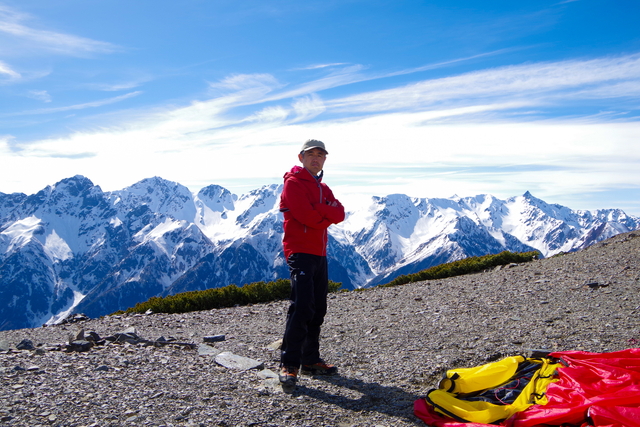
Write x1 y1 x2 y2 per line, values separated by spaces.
0 0 640 215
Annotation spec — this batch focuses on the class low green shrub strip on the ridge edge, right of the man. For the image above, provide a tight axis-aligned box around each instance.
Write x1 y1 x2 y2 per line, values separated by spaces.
381 251 540 287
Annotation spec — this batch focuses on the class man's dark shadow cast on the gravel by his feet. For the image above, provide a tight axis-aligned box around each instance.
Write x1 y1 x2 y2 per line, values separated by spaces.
291 375 424 426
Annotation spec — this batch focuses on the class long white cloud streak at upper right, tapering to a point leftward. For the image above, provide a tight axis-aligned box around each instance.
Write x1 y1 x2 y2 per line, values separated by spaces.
327 55 640 112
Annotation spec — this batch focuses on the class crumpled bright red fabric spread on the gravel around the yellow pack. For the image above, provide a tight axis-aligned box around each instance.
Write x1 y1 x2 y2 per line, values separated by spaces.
414 348 640 427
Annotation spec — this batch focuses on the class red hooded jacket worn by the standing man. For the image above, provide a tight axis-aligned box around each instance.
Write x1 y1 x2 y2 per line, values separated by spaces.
280 166 344 258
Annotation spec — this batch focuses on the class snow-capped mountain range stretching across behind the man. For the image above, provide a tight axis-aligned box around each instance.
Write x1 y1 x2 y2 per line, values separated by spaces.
0 176 640 329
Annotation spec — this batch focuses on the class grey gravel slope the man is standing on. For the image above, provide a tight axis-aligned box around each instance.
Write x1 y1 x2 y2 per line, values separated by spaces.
0 233 640 427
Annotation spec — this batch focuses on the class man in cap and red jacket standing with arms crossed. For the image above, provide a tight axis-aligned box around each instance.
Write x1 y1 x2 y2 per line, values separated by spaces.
279 139 344 387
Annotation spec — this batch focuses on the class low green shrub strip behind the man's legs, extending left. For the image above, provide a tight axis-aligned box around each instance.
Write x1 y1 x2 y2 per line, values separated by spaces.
114 279 342 314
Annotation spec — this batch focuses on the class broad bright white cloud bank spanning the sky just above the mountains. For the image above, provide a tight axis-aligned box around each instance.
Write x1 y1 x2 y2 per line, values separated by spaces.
0 55 640 214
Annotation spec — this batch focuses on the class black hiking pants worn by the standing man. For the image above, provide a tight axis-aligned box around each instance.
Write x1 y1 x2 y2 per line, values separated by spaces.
280 253 329 367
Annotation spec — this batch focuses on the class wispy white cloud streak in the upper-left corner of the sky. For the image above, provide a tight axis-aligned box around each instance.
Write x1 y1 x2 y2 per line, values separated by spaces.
0 5 121 56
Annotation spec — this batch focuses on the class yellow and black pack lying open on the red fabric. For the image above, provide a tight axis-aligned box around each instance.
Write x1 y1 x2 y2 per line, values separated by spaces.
425 356 562 424
